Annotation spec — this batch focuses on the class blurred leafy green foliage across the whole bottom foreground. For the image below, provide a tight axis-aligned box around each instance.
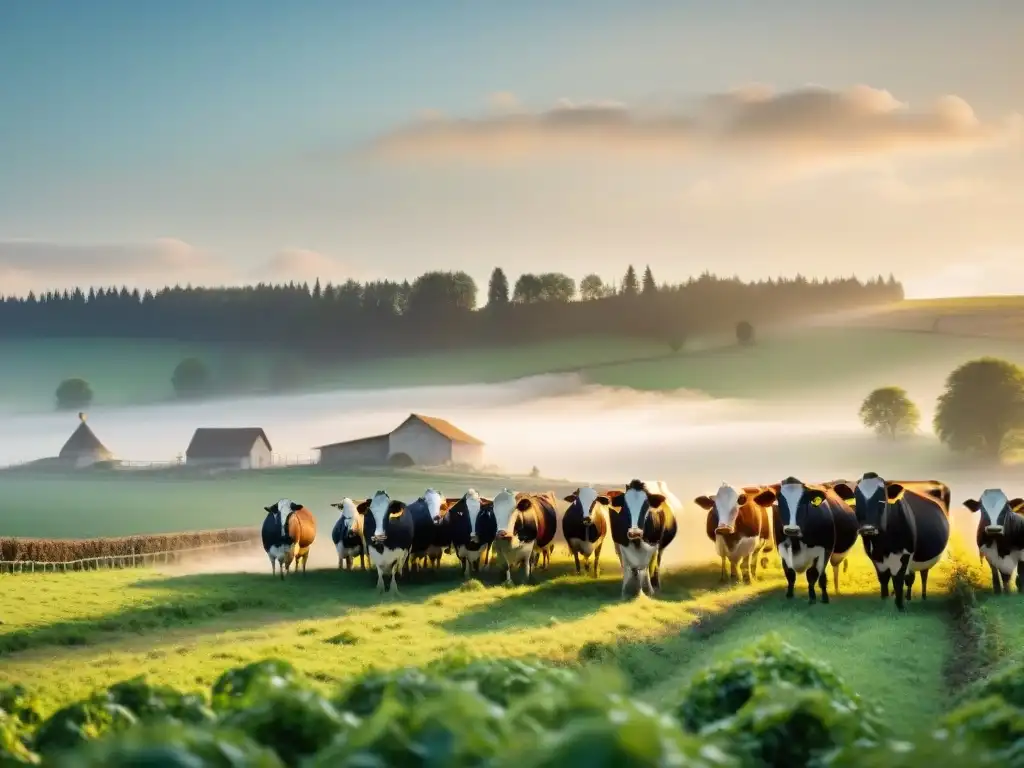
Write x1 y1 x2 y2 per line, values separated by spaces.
0 636 1024 768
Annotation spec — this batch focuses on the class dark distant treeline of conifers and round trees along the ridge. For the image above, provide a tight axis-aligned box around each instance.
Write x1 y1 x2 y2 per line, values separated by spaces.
0 266 903 354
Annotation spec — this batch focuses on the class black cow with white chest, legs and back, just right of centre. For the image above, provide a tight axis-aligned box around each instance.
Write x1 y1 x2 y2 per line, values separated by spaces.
603 479 683 597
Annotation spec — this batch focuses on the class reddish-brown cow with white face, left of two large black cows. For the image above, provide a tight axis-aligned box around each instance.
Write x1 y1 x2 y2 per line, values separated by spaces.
693 483 772 584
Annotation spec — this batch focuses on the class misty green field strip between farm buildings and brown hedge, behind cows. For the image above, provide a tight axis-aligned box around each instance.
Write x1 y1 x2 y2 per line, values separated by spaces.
0 468 575 539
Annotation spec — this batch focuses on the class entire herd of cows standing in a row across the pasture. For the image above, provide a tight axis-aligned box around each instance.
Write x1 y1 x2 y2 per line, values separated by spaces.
262 472 1024 610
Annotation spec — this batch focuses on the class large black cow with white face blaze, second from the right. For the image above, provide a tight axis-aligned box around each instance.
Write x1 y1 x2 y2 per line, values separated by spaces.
833 472 949 610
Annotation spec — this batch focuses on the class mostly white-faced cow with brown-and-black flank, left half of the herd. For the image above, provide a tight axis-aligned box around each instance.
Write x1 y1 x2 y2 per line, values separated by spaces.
490 488 558 585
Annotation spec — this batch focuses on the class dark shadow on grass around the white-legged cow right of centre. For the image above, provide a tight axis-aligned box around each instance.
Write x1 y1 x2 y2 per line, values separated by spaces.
441 565 719 634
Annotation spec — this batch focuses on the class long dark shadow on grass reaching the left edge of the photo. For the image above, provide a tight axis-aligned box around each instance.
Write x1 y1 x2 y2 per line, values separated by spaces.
0 568 468 658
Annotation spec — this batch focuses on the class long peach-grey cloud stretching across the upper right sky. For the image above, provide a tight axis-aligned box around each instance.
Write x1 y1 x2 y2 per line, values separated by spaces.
369 85 1020 162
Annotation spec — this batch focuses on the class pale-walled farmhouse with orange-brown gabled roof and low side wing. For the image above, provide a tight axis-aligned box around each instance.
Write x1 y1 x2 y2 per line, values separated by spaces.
316 414 483 467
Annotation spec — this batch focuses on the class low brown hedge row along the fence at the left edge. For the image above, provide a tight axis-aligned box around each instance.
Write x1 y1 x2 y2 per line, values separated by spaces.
0 527 260 563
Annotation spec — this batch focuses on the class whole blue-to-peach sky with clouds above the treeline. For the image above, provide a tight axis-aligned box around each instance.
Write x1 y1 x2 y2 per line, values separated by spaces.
0 0 1024 300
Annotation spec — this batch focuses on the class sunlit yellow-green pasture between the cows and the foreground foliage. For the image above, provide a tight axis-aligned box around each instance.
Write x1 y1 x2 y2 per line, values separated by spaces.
0 542 951 729
